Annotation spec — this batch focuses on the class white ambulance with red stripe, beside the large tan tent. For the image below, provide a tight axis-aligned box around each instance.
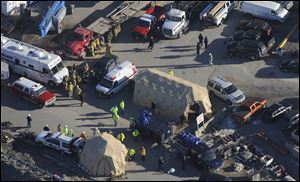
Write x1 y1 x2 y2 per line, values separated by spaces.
96 61 138 96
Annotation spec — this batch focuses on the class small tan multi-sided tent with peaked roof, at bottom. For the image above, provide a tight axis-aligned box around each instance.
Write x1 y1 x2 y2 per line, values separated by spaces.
79 132 127 177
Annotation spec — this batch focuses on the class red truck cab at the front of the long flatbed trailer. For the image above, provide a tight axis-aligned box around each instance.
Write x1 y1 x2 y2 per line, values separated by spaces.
67 27 92 58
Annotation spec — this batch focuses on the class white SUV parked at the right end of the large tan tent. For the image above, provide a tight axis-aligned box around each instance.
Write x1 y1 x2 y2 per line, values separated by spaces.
207 76 246 105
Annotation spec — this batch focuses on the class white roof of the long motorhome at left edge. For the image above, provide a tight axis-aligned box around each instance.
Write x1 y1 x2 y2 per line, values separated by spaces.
1 35 59 67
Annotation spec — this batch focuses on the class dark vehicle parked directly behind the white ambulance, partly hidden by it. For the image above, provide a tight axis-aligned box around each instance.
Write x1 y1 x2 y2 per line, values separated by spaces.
93 55 118 83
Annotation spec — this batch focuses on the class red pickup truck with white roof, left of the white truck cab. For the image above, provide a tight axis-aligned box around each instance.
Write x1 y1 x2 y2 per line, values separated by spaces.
133 6 166 39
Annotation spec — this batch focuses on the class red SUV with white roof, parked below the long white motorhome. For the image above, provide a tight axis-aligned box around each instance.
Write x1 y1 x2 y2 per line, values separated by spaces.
11 77 56 108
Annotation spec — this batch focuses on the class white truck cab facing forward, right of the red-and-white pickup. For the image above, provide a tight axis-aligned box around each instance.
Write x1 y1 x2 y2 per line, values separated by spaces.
162 9 188 39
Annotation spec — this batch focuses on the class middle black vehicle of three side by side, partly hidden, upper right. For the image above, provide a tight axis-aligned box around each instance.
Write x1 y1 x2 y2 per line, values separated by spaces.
233 29 275 49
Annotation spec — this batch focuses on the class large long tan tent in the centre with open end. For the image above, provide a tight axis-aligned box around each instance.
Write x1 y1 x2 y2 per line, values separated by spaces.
133 69 212 120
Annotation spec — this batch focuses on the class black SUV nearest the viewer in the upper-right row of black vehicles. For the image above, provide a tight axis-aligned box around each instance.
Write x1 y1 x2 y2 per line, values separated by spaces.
227 39 267 60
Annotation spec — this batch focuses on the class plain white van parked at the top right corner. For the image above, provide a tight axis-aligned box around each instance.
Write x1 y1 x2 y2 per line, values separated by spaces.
241 1 288 23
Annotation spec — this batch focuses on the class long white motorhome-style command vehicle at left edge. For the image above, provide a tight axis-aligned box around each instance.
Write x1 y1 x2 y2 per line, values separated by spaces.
1 35 69 87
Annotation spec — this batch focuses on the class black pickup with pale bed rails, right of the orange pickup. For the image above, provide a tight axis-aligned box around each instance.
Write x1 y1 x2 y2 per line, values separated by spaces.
263 103 291 121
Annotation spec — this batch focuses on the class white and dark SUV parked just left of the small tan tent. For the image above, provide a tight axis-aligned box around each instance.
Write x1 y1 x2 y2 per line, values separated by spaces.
35 131 85 155
